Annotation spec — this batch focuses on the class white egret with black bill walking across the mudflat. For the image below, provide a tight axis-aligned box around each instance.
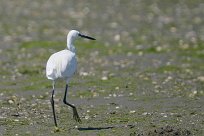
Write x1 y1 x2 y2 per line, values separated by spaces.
46 30 95 127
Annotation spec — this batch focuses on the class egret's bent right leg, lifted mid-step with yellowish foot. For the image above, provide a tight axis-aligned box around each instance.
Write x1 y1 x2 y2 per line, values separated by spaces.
63 84 81 122
